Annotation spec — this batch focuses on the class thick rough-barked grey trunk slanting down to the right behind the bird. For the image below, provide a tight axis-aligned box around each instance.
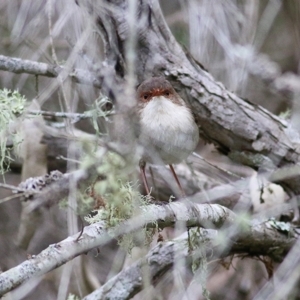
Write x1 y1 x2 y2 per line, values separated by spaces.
79 0 300 193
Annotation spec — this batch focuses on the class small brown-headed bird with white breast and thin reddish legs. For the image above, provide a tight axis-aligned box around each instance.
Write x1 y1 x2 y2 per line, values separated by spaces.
137 77 199 196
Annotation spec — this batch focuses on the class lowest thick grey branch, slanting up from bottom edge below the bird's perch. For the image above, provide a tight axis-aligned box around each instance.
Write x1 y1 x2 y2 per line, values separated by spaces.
84 220 294 300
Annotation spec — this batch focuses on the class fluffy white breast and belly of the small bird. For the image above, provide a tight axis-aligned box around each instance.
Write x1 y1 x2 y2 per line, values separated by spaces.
139 96 199 164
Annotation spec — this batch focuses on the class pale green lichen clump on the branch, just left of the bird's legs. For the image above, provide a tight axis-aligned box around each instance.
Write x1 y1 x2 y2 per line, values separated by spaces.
85 152 154 252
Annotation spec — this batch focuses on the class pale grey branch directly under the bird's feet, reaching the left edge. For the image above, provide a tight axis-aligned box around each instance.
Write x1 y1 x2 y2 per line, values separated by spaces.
0 203 234 296
